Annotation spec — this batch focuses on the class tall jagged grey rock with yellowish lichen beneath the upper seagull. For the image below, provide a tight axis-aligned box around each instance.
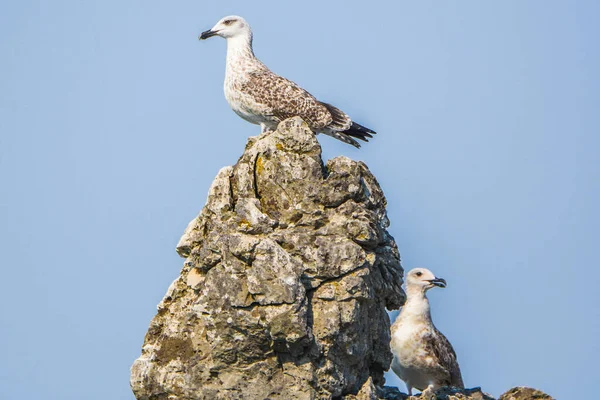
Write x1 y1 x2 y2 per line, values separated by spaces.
131 118 405 400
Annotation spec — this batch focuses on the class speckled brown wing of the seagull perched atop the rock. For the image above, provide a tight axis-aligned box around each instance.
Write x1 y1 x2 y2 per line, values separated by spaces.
240 70 333 131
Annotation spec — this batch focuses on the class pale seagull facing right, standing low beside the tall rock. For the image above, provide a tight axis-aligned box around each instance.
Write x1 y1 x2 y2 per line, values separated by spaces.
390 268 464 396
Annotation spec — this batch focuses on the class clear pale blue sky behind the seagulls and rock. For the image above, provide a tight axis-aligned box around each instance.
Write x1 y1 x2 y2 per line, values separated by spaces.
0 0 600 400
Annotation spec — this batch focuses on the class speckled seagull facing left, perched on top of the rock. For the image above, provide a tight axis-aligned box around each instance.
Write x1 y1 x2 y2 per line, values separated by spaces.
198 15 375 148
